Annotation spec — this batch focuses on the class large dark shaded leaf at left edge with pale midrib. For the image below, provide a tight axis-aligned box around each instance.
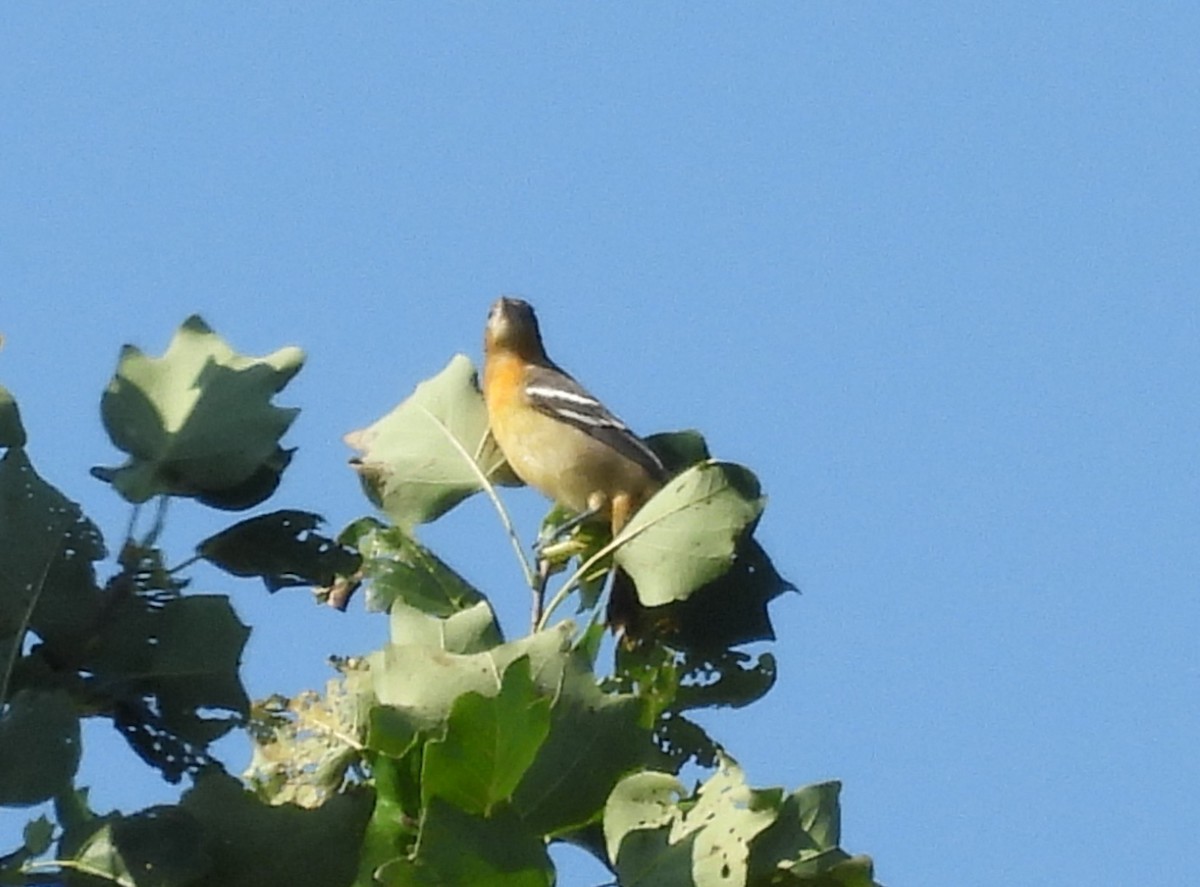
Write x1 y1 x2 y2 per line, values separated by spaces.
0 449 104 657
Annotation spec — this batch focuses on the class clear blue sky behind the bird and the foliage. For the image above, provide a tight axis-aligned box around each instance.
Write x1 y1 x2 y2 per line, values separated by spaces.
0 2 1200 887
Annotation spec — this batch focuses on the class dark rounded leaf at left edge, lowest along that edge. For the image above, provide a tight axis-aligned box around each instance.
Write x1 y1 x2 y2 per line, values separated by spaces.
0 690 79 807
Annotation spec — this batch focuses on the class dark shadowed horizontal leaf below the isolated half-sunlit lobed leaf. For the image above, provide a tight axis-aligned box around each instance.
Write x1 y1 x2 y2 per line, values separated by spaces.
196 510 361 592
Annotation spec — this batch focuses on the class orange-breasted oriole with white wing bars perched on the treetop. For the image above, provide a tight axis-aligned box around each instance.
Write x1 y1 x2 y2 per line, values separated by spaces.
484 298 666 628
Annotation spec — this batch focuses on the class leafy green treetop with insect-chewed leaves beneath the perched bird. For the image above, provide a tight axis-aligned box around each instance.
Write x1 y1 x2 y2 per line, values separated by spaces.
0 317 874 887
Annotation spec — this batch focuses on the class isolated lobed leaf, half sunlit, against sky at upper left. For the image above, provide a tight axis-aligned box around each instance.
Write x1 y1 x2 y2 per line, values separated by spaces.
92 316 304 509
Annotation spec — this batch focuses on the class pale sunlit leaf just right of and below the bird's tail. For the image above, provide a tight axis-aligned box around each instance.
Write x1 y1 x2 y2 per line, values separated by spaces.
613 461 766 606
